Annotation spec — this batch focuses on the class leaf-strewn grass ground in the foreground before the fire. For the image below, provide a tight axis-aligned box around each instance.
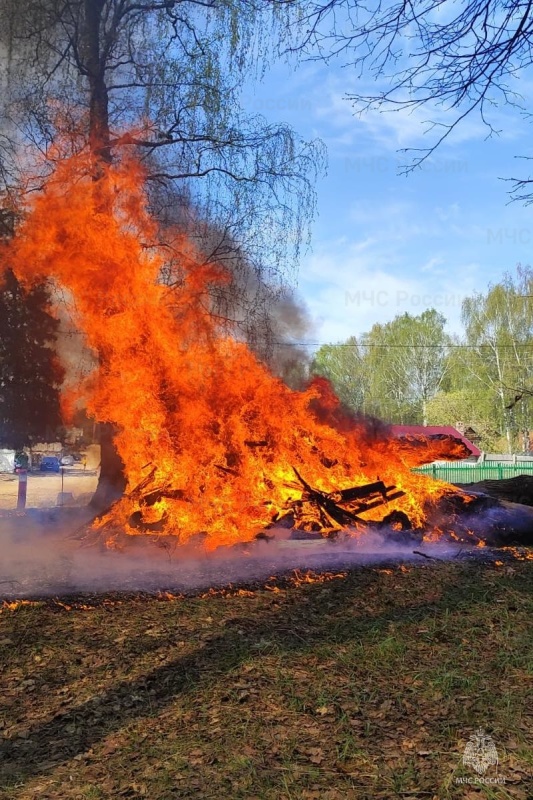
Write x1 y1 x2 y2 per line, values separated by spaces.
0 561 533 800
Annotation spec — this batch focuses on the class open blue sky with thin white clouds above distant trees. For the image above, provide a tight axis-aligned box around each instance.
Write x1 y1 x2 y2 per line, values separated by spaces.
240 56 533 342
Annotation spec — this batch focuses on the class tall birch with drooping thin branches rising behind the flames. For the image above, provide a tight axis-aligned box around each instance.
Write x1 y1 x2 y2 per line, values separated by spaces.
0 0 323 505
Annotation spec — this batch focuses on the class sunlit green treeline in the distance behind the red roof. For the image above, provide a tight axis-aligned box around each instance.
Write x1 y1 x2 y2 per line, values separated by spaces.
312 265 533 452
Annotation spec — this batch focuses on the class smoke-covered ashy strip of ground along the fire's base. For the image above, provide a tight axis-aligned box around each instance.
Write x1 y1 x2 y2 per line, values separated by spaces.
0 500 531 599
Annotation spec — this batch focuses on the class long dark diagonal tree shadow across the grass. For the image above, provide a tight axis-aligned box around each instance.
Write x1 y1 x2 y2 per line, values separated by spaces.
0 570 524 781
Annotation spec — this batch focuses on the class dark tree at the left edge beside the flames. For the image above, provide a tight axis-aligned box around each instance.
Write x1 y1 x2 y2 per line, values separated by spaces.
0 270 63 449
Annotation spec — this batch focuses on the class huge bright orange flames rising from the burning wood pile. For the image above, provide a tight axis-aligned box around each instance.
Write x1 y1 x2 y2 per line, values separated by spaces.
4 150 465 548
